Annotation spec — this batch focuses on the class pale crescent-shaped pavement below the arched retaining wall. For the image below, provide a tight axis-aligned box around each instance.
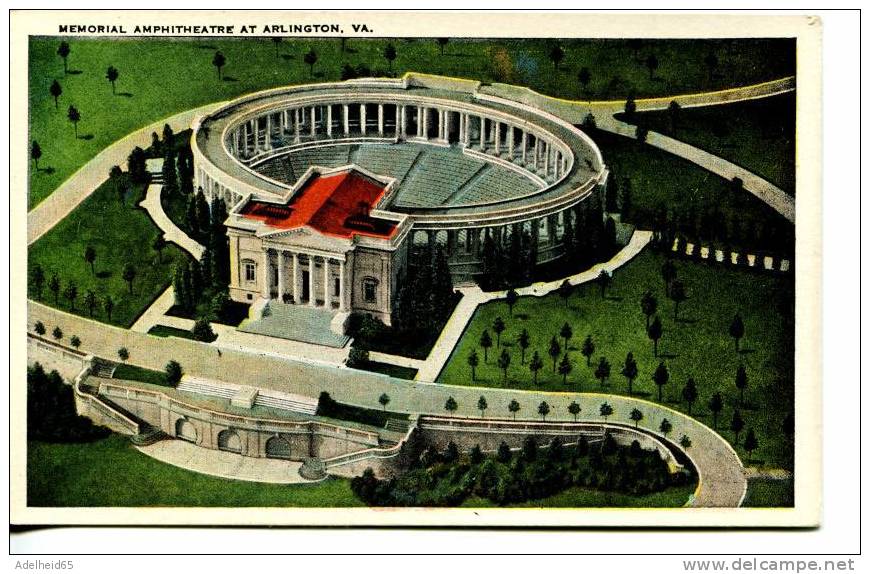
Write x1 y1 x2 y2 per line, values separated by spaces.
136 439 316 484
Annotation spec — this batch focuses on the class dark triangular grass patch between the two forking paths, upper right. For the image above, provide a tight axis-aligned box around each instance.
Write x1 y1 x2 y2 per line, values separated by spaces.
623 92 795 195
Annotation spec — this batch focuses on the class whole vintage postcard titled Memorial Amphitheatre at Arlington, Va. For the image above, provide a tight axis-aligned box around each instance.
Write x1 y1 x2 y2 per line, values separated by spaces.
10 10 822 527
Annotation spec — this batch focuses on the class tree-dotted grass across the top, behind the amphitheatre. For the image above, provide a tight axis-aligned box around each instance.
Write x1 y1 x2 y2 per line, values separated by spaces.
29 37 795 209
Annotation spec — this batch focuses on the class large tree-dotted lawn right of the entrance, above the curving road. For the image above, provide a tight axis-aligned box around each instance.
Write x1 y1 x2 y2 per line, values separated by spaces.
437 250 794 468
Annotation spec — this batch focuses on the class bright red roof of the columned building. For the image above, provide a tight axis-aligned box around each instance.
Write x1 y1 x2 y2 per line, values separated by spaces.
239 170 396 239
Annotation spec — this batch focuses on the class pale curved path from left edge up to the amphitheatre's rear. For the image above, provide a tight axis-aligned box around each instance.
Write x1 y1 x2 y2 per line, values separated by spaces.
27 102 224 245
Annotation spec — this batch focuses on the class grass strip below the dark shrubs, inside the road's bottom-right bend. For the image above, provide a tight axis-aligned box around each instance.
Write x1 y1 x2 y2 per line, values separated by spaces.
461 484 697 508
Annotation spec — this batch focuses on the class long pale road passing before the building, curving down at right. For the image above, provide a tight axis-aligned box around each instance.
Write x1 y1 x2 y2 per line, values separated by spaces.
28 301 746 507
